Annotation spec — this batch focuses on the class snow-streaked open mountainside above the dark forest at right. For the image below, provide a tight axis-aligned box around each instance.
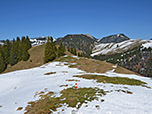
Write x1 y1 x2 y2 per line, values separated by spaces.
91 40 152 56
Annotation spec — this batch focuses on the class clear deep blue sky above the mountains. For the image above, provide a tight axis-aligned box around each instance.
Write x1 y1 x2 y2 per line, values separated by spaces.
0 0 152 40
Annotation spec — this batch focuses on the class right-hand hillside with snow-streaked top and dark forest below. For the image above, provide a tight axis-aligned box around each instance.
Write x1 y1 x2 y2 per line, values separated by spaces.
91 40 152 77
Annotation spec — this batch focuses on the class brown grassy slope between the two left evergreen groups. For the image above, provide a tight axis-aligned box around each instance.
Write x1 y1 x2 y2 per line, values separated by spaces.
4 45 45 73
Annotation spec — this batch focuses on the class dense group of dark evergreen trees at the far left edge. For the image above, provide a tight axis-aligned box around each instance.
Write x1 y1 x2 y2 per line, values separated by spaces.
0 36 32 72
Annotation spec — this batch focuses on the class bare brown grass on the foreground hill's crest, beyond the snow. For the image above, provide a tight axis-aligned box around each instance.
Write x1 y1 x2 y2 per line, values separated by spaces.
57 56 113 73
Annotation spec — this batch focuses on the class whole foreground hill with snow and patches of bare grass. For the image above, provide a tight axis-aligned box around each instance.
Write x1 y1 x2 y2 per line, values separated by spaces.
0 56 152 114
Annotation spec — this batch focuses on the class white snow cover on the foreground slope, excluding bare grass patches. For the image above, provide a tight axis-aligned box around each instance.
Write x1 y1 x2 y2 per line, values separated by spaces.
0 58 152 114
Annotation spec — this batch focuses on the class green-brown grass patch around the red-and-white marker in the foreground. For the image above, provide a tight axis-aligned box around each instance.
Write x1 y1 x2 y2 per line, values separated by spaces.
24 88 106 114
